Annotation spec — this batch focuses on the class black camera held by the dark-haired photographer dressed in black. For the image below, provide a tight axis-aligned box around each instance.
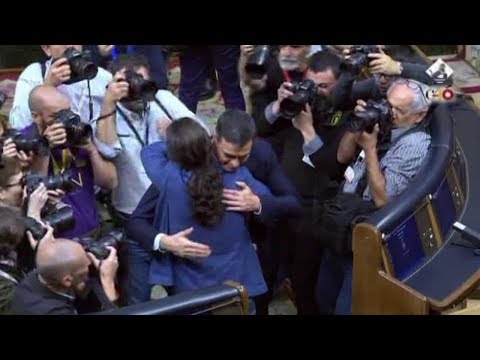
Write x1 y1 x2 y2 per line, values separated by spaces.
280 79 318 119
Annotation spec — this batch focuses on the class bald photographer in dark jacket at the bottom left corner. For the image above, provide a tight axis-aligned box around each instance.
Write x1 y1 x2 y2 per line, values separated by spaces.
12 239 118 315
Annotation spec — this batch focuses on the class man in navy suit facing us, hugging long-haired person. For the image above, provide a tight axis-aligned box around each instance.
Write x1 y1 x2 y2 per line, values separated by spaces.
125 110 302 314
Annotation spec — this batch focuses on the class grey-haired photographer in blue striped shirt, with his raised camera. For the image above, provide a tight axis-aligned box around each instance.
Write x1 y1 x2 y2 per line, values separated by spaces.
316 79 430 315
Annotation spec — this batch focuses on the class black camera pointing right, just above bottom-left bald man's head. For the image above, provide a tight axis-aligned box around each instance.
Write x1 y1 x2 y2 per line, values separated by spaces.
25 206 75 241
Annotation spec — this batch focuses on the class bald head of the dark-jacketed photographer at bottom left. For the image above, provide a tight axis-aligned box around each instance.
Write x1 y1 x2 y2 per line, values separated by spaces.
36 239 90 286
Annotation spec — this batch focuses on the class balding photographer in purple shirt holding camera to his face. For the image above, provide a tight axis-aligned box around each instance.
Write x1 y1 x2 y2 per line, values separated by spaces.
22 85 117 239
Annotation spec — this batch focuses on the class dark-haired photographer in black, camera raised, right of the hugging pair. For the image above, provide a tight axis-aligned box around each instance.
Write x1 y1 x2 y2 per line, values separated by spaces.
257 51 360 314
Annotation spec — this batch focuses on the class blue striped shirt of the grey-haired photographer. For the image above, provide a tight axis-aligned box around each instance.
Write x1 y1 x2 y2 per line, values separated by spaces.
343 127 431 201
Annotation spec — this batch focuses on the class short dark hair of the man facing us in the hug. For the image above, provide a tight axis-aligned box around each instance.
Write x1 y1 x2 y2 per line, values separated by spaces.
215 109 257 146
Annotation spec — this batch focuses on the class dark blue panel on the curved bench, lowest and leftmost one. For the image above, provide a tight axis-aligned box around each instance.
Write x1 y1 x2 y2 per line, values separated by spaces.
385 208 427 280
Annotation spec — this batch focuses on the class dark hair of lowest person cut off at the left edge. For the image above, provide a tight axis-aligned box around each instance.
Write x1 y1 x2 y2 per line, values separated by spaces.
0 206 25 256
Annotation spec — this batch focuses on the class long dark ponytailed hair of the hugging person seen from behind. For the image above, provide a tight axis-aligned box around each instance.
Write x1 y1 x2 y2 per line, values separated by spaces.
167 118 225 226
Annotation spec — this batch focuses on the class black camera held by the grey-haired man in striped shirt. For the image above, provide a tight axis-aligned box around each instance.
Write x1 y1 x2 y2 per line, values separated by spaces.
349 99 393 137
